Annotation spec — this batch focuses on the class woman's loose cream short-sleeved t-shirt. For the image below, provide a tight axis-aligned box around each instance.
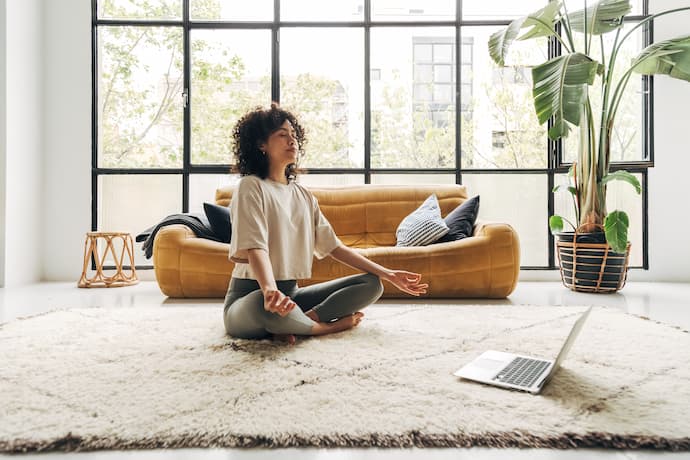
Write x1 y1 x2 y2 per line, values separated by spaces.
230 175 341 280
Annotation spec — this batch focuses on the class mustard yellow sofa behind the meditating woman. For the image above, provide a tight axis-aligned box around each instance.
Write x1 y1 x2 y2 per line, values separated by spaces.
153 185 520 298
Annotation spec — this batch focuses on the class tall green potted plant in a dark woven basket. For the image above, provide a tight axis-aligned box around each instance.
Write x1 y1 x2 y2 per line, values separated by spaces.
489 0 690 292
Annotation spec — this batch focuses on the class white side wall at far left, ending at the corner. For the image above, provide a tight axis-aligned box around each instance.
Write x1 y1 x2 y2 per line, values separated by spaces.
4 0 44 286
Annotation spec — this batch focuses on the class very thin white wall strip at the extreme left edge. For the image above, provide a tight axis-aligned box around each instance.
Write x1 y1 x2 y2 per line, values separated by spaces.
0 0 7 288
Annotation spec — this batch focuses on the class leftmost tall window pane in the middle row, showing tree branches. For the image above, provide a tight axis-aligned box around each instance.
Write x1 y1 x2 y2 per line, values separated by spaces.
98 27 183 168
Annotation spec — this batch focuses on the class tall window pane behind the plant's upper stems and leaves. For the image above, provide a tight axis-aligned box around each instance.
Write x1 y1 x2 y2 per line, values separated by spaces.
563 25 644 163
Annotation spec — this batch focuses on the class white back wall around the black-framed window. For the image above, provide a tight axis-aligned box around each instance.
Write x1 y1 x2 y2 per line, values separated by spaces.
30 0 690 282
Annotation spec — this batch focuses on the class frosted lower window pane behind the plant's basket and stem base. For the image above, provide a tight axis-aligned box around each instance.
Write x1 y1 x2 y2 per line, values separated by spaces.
554 173 643 267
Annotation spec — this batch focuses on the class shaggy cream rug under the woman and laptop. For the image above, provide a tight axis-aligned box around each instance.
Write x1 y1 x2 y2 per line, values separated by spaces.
0 305 690 452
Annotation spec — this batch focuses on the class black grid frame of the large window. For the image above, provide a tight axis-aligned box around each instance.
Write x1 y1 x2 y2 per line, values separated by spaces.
91 0 654 270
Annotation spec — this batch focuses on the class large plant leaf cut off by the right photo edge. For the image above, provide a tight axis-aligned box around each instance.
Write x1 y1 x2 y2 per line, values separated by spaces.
633 35 690 81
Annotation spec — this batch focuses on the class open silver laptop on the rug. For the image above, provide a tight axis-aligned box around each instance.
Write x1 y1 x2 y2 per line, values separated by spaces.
454 307 592 394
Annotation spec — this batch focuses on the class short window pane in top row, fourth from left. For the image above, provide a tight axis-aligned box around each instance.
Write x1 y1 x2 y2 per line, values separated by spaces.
371 0 456 21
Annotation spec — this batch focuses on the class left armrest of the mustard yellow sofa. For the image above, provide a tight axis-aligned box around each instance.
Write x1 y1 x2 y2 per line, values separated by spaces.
153 224 234 297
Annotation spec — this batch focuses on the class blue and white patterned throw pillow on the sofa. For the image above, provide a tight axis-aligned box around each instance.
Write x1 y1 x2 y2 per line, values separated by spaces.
395 195 448 246
